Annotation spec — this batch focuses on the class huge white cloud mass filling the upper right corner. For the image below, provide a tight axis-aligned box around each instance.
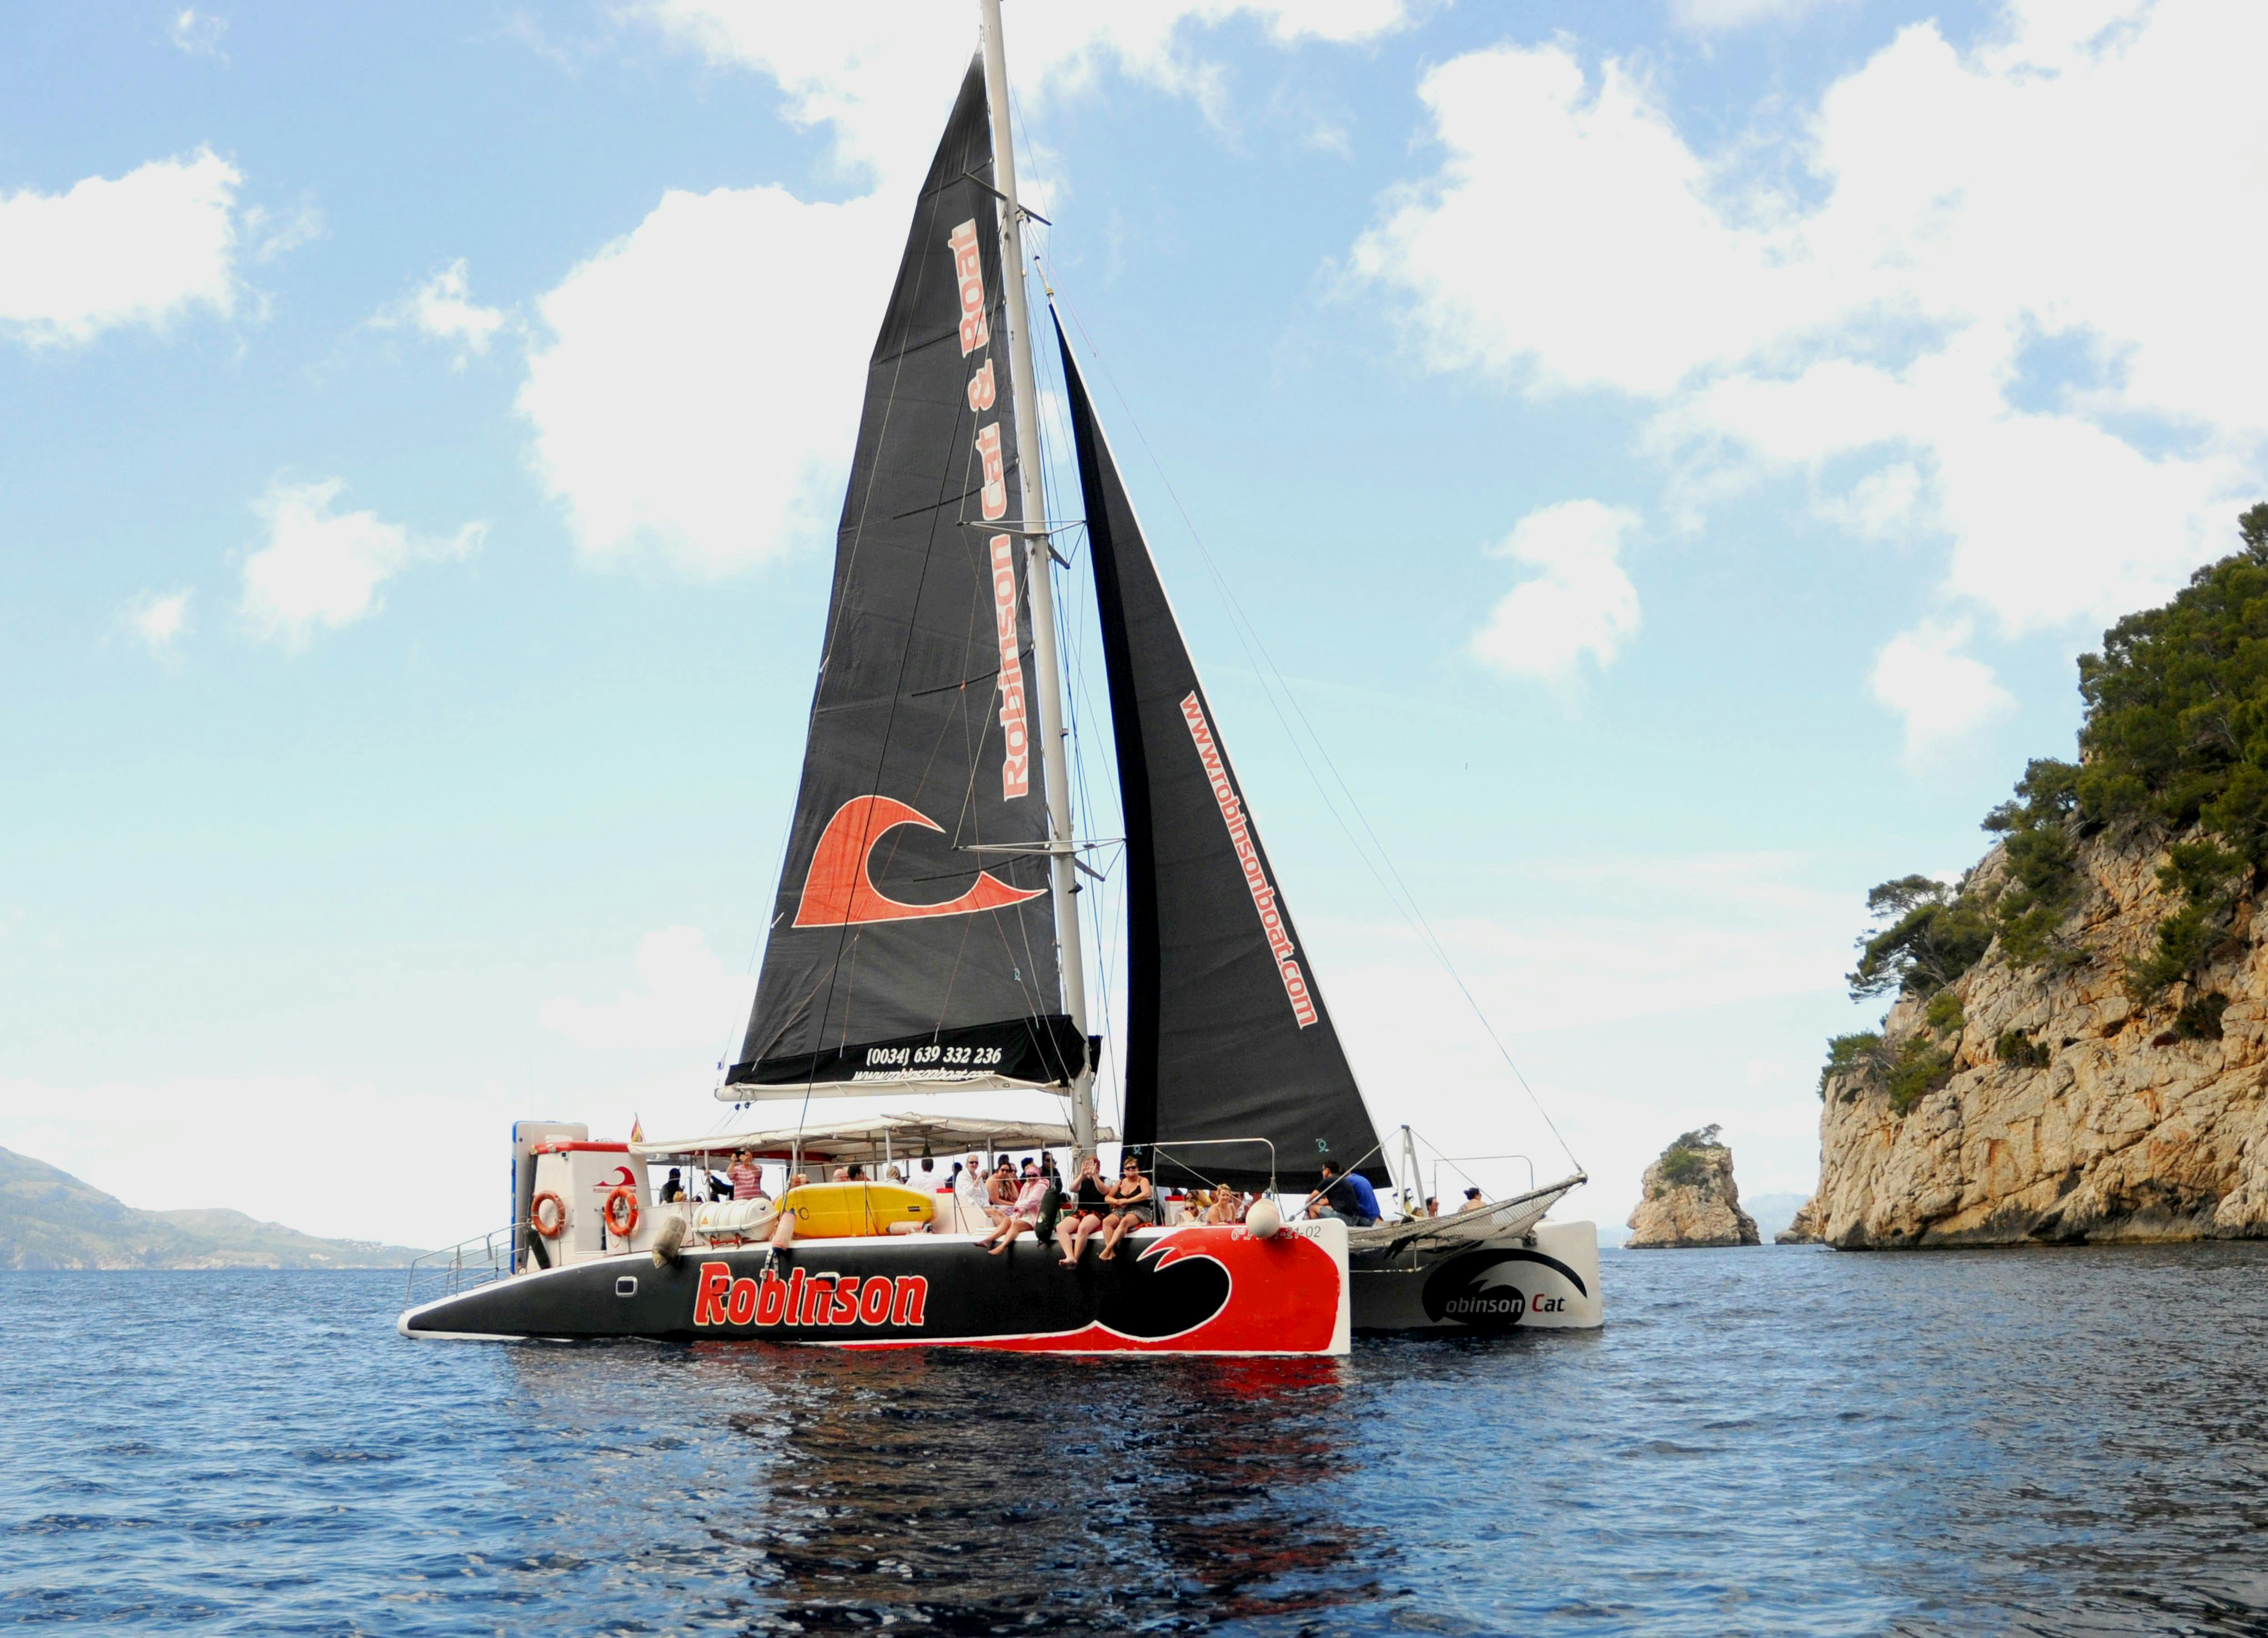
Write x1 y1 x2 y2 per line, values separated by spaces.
1352 0 2268 633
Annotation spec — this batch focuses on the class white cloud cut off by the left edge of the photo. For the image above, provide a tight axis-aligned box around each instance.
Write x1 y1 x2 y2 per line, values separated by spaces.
0 150 243 347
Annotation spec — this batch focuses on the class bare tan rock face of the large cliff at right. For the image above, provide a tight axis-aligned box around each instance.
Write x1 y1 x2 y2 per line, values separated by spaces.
1796 830 2268 1248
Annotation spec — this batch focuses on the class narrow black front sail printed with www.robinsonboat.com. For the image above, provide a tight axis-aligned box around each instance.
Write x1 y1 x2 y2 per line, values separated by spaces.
1057 327 1388 1187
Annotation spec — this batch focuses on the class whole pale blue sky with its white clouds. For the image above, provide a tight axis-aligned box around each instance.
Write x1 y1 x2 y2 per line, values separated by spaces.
0 0 2268 1245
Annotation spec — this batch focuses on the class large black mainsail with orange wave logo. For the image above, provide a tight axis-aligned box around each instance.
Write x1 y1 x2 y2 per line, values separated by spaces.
719 63 1086 1098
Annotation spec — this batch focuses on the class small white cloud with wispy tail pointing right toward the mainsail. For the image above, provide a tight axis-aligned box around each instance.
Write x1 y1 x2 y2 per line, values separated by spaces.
243 479 487 649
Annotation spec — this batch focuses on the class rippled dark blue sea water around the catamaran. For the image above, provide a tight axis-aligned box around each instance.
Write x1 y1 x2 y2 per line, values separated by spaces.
0 1245 2268 1636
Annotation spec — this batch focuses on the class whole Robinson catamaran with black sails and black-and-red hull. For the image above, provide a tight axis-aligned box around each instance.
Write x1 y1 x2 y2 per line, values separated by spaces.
399 0 1601 1354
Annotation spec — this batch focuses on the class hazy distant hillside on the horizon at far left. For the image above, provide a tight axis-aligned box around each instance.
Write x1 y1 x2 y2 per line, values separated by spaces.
0 1148 417 1268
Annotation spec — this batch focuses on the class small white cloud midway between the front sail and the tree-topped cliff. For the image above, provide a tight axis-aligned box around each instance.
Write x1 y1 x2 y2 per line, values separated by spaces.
1472 502 1638 683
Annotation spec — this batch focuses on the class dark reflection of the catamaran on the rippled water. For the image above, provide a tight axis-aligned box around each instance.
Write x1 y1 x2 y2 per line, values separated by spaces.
687 1346 1383 1631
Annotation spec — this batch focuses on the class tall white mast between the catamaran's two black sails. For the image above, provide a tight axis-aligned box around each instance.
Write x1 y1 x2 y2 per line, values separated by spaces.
978 0 1096 1168
